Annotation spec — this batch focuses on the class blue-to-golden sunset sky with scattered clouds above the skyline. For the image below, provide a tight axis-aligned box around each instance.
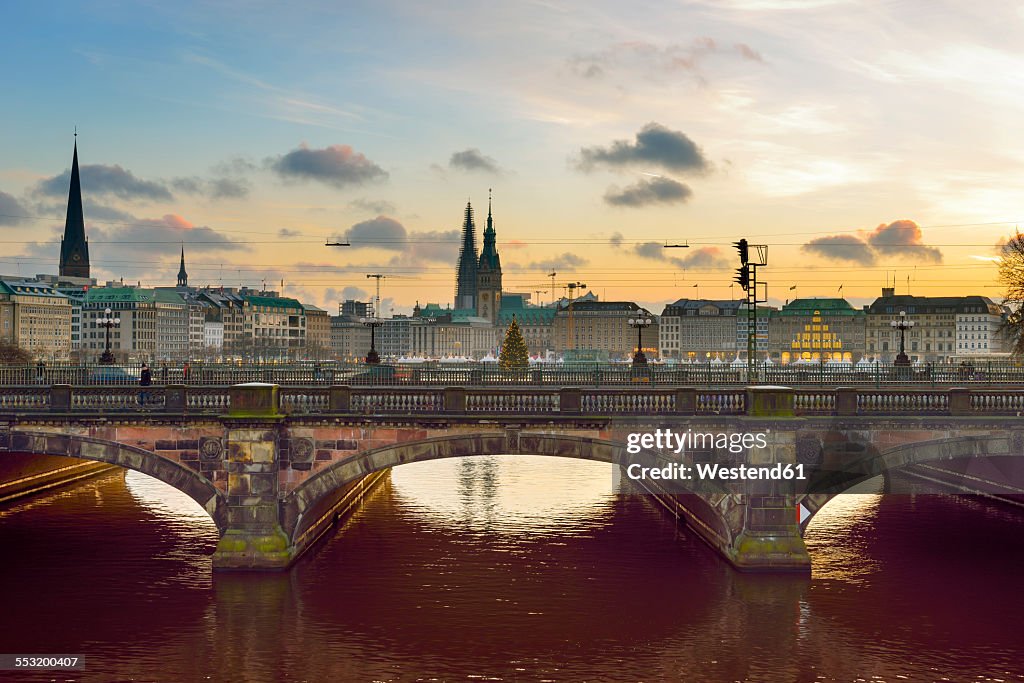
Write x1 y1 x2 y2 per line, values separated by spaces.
0 0 1024 314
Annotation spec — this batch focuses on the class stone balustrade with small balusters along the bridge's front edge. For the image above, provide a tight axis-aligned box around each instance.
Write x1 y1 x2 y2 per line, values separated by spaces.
6 384 1024 418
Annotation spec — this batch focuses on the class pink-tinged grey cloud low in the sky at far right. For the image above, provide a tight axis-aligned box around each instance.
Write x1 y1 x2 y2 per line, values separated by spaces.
801 219 942 265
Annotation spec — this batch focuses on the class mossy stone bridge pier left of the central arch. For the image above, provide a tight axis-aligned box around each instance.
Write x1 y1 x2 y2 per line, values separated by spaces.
213 383 296 571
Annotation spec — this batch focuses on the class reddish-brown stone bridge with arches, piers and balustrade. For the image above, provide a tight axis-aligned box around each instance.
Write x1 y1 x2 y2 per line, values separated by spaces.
0 384 1024 570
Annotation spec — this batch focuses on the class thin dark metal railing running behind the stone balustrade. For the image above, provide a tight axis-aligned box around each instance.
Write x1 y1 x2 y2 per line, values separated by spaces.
6 361 1024 388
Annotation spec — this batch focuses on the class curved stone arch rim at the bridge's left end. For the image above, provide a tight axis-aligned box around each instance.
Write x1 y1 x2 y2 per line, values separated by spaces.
7 430 227 531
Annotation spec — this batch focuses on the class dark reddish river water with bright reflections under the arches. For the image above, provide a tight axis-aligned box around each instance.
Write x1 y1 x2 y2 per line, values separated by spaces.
0 456 1024 682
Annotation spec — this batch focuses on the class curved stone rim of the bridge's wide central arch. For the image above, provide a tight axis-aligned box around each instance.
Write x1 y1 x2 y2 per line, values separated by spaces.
282 431 733 541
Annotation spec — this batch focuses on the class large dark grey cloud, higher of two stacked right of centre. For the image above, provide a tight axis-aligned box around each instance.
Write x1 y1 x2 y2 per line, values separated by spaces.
577 122 710 172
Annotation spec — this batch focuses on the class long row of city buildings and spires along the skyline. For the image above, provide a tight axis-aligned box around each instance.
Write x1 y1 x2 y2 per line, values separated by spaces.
6 138 1012 364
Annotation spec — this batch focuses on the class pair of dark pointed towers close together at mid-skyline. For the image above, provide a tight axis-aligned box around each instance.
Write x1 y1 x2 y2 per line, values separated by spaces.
455 194 502 325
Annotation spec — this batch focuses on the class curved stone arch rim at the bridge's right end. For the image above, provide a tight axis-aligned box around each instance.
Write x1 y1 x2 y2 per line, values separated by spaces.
797 430 1024 531
